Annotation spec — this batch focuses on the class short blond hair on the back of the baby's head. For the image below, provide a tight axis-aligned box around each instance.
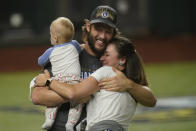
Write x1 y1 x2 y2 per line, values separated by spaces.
51 17 75 42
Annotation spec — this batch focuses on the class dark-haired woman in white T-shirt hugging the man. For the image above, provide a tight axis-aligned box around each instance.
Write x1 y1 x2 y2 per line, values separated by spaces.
35 37 148 131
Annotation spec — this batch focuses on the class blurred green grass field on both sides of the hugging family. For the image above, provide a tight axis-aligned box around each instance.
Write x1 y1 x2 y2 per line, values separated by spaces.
0 62 196 131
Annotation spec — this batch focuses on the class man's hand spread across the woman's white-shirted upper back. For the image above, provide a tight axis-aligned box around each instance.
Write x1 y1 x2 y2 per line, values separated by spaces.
98 68 130 92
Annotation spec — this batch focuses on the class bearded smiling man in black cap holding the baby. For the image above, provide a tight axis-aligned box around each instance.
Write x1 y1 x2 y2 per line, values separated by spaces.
32 6 156 131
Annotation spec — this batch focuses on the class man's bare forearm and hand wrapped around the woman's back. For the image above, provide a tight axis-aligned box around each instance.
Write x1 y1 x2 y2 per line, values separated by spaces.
99 69 156 107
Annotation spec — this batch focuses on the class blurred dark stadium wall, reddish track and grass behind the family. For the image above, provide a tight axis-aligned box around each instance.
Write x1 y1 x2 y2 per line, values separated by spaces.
0 0 196 131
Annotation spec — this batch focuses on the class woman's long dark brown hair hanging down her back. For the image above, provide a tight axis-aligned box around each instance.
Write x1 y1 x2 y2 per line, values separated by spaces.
109 36 148 86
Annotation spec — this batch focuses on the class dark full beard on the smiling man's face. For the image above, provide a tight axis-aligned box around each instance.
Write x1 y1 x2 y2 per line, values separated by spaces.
87 32 107 57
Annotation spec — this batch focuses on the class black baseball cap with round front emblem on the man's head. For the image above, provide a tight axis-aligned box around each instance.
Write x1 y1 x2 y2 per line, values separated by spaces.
90 5 117 28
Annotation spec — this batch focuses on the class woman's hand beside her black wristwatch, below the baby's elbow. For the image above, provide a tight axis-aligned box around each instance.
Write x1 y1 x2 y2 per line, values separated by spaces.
35 70 50 87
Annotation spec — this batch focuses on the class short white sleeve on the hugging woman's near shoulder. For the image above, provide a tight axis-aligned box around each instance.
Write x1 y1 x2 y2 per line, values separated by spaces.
91 66 116 82
